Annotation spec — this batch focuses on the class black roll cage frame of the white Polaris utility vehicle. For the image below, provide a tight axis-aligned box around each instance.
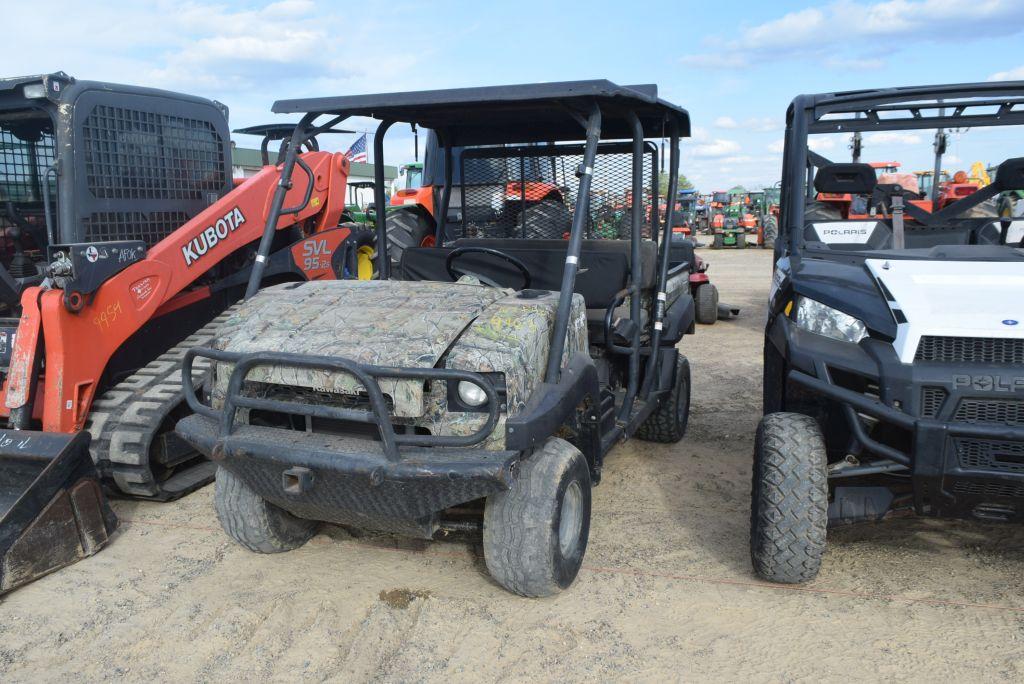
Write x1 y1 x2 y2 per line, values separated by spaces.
775 81 1024 259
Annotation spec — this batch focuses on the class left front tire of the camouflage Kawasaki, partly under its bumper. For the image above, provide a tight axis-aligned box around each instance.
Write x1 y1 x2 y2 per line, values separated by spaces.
213 468 317 553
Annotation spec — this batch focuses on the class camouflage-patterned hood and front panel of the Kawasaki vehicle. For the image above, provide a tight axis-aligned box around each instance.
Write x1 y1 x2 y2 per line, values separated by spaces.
215 281 508 417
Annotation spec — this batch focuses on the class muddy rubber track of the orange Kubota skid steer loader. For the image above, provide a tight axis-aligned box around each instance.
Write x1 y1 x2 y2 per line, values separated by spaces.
85 305 238 501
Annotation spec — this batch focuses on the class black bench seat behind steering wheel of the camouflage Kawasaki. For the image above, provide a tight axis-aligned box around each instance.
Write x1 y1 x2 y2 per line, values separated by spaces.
400 238 657 309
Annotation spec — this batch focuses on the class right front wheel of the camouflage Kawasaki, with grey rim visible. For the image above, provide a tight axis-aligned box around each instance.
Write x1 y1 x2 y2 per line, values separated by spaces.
483 437 591 597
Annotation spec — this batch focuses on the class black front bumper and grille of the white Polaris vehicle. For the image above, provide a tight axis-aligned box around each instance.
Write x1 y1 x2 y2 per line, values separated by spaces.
769 316 1024 521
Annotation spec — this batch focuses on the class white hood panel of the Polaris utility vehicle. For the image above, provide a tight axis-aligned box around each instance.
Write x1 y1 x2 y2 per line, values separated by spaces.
865 259 1024 364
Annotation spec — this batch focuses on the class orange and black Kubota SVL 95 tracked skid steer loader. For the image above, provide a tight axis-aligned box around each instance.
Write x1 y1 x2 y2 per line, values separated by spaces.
0 73 373 593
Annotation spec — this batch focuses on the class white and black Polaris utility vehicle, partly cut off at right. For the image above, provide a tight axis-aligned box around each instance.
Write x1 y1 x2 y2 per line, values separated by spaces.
751 82 1024 583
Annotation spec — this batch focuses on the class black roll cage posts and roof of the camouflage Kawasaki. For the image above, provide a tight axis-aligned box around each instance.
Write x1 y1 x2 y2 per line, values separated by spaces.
238 81 690 395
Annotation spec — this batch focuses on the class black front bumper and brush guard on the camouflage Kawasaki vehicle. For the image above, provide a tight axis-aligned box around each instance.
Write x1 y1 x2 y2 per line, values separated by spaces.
177 348 519 539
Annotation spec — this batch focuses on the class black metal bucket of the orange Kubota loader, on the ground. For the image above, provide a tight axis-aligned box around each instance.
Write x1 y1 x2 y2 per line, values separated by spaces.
0 430 118 594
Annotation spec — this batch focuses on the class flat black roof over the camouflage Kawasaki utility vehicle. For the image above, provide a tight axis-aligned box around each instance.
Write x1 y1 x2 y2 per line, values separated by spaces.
273 81 690 145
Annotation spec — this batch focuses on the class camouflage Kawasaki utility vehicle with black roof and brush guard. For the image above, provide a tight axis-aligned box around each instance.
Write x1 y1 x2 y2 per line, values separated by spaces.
177 81 694 596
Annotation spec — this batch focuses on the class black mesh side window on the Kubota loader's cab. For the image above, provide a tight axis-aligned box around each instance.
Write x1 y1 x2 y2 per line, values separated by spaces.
82 104 226 202
